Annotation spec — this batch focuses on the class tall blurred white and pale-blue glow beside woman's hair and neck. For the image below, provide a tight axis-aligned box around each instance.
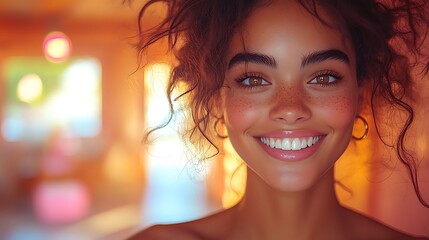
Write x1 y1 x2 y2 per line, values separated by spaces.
141 63 210 224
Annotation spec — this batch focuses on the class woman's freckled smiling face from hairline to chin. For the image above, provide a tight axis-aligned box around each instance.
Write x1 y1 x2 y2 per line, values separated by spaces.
222 1 358 191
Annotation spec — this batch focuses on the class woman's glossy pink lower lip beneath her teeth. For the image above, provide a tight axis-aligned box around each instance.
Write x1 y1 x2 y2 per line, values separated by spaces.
257 135 325 162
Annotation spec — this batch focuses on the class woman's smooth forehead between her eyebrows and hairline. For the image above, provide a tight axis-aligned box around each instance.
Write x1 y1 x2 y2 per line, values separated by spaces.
228 1 354 64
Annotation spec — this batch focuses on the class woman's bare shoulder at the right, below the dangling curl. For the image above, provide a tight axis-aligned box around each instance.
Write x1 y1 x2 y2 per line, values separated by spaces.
349 207 429 240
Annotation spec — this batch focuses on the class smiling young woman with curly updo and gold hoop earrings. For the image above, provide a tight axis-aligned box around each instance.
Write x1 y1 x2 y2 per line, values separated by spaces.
133 0 428 240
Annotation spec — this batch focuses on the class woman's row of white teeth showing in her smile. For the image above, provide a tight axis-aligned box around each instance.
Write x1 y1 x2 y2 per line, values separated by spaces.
259 136 322 151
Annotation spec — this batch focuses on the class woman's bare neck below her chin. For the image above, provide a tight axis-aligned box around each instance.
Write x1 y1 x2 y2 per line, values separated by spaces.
231 169 345 239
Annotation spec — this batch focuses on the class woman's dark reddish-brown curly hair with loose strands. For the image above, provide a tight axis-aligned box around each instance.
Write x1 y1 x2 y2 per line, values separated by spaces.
132 0 429 207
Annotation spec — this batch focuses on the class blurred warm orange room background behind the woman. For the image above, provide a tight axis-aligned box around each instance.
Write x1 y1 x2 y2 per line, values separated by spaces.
0 0 429 240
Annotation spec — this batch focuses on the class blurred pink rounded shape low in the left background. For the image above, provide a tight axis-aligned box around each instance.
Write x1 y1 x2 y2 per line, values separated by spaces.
33 180 90 224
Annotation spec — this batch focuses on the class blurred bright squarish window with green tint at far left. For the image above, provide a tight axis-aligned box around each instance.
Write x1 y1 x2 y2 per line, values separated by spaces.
0 57 102 142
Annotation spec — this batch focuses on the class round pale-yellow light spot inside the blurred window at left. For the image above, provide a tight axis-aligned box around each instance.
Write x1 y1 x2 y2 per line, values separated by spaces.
16 73 43 103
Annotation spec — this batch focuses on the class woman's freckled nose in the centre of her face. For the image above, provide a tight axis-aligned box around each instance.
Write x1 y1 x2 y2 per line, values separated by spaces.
270 87 311 124
